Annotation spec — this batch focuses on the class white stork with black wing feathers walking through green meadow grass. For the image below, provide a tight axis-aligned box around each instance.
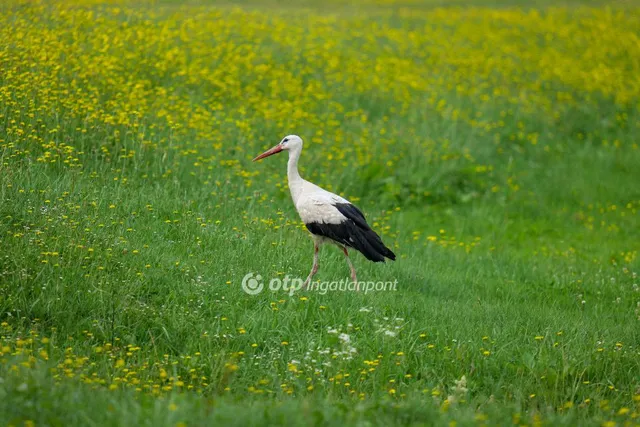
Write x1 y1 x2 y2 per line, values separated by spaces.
253 135 396 287
